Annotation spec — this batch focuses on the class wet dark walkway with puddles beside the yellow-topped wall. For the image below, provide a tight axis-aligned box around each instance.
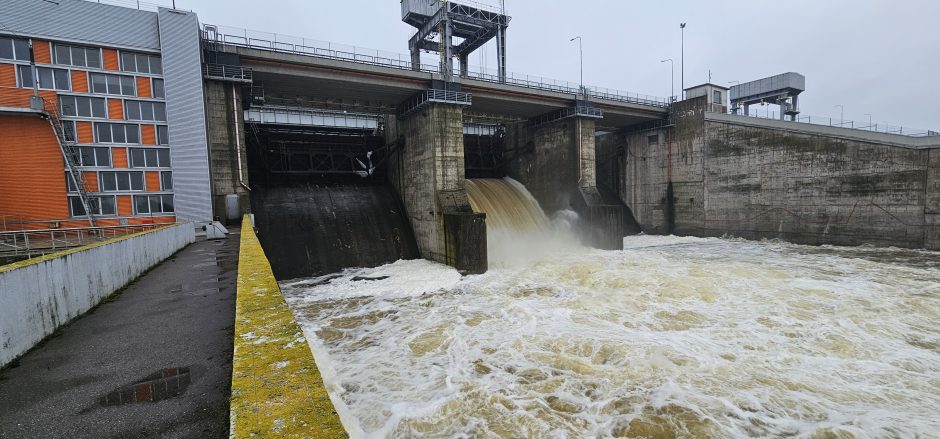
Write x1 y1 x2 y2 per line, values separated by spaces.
0 229 239 438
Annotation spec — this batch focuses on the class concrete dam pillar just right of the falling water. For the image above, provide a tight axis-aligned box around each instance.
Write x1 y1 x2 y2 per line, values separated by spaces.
507 116 625 250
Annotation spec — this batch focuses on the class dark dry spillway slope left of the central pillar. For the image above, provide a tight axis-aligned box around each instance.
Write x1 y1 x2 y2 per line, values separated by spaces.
252 183 419 279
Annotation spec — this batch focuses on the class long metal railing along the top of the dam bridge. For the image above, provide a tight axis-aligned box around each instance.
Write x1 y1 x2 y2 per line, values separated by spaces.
202 24 669 108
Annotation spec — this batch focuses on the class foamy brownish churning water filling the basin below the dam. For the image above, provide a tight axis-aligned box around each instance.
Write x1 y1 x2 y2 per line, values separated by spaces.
283 182 940 438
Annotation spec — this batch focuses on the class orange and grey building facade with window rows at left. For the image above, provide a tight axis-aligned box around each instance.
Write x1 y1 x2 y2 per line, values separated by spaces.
0 0 212 228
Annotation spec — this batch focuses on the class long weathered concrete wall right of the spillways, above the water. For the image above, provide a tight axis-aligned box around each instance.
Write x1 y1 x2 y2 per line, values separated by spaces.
598 99 940 249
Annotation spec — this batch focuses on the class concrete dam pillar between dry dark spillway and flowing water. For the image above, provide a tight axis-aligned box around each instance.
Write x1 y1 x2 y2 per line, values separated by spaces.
390 89 487 274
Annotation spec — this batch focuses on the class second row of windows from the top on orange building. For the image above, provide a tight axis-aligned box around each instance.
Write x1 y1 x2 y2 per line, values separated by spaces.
16 65 166 99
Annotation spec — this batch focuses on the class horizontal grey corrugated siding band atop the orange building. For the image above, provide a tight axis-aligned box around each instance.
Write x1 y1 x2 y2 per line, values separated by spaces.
0 0 160 50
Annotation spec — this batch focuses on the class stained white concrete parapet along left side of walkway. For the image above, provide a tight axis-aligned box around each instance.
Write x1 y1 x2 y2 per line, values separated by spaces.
0 223 196 367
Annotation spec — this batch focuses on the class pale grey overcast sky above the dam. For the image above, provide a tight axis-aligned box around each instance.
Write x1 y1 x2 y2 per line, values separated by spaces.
178 0 940 130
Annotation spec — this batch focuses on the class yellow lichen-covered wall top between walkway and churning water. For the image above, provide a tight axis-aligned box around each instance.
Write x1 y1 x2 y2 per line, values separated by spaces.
230 216 348 438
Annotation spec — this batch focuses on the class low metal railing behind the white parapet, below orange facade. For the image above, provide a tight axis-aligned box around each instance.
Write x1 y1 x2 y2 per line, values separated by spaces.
0 224 165 257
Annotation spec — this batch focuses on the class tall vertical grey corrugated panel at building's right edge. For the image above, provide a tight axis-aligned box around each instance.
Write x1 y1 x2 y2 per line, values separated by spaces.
158 8 212 221
